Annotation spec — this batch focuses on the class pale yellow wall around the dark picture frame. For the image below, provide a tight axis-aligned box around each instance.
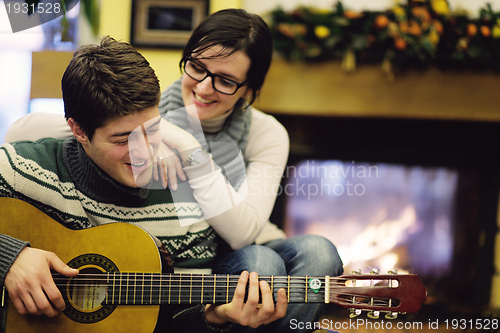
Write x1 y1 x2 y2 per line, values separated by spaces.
100 0 241 90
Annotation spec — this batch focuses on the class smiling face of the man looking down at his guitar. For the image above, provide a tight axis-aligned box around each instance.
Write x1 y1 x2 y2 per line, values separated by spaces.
77 107 161 187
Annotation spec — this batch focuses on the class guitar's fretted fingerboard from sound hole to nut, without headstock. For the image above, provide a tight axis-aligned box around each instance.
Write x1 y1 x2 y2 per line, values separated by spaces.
103 273 329 305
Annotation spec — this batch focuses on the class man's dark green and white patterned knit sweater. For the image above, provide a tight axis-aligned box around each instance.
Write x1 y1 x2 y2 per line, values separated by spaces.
0 138 230 332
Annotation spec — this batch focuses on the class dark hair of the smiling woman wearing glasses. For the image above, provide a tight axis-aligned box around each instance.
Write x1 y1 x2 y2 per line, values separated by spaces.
179 9 273 104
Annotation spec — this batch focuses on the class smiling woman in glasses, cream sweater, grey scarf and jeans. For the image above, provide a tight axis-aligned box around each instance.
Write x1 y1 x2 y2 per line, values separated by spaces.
6 9 343 332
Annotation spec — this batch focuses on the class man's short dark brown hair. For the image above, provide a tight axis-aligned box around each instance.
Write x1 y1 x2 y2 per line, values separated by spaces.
61 36 160 140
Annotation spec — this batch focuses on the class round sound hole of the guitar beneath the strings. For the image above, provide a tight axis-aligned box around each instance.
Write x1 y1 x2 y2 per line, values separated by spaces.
68 268 108 312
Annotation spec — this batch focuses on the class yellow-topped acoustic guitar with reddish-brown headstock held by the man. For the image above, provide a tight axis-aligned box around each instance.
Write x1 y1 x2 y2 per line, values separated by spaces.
0 198 427 333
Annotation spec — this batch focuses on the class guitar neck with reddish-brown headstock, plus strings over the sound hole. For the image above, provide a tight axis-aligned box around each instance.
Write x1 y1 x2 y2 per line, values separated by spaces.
70 272 427 313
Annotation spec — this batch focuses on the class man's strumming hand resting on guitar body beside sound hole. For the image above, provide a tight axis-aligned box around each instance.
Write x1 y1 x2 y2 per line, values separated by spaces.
5 247 78 317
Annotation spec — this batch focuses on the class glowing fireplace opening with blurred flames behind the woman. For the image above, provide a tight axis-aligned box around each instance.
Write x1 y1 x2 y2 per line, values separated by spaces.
285 160 458 279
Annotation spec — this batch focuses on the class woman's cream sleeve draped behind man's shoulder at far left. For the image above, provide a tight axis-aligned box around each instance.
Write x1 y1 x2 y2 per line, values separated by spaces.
5 112 73 142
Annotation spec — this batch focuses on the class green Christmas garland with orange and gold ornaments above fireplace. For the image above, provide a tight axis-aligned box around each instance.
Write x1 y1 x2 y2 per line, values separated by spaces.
270 0 500 78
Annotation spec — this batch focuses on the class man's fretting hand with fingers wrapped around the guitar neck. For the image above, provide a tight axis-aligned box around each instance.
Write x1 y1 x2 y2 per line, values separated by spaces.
205 272 288 328
